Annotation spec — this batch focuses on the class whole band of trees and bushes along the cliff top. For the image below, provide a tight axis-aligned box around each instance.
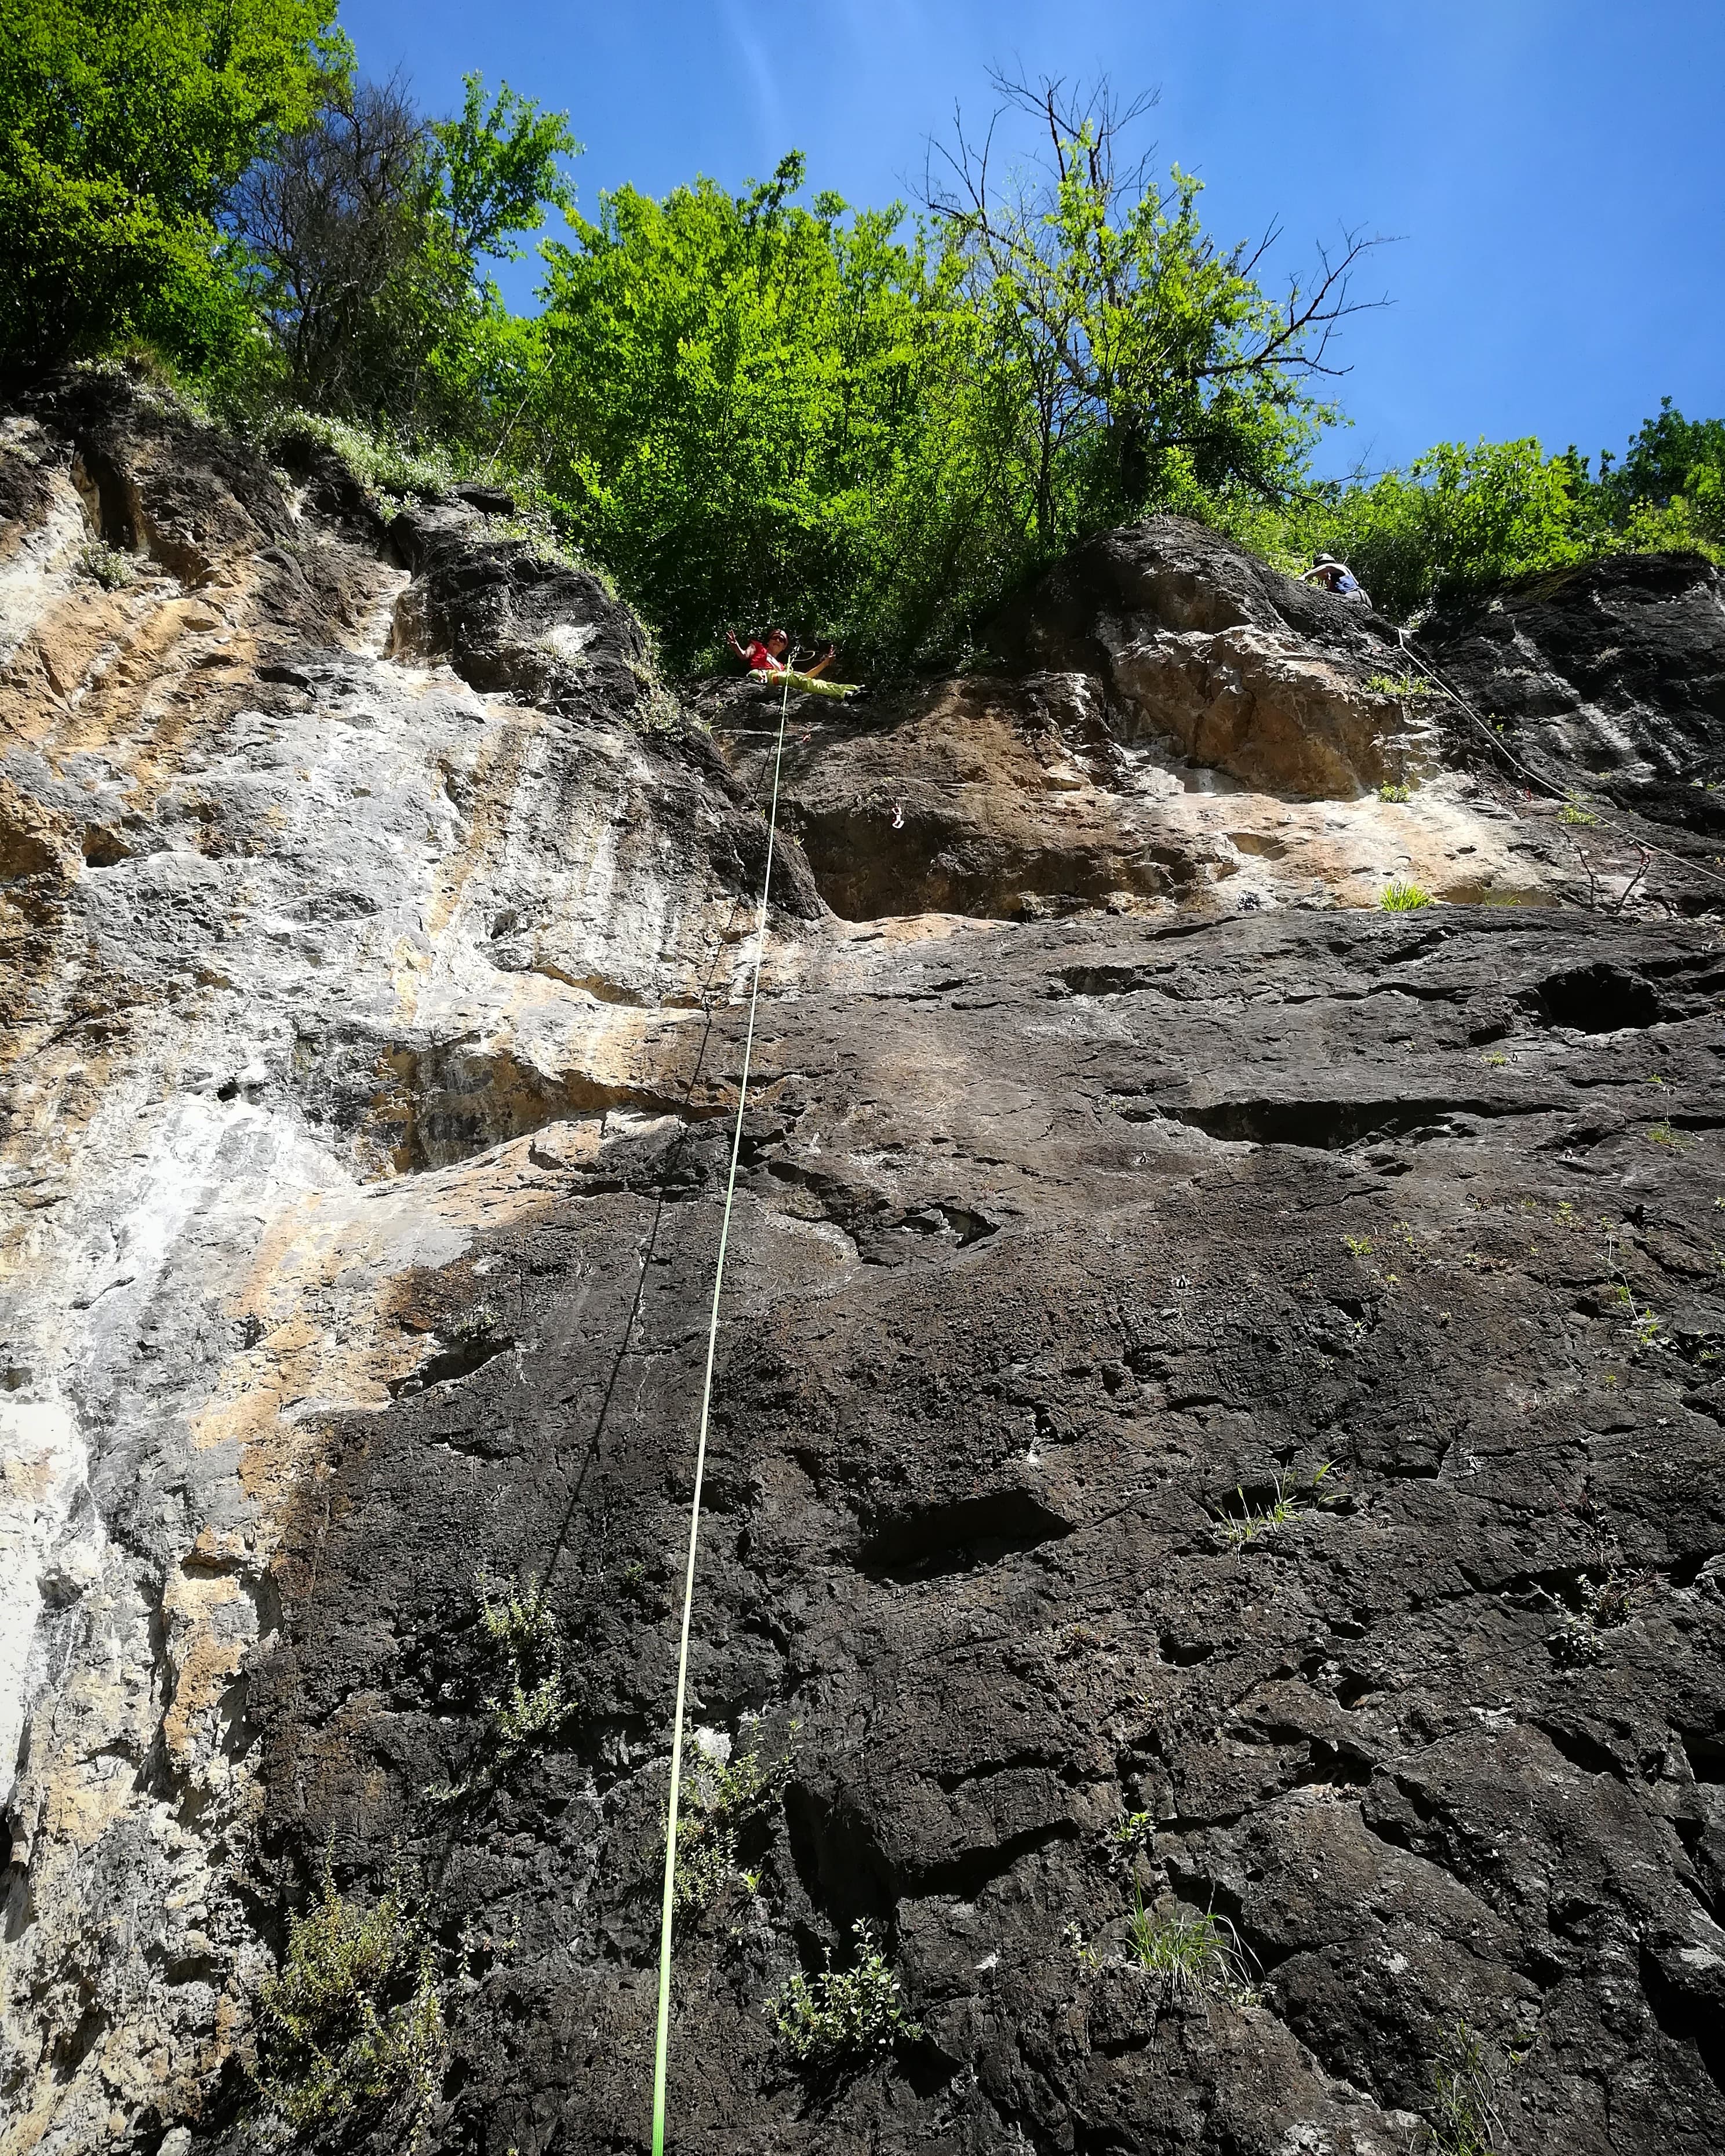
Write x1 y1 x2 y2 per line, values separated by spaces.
0 19 1725 675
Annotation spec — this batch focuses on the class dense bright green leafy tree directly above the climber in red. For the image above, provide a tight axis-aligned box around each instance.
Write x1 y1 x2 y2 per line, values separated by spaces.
530 155 970 662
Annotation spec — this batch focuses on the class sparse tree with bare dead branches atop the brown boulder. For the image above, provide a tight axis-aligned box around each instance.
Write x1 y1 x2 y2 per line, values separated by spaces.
929 75 1371 558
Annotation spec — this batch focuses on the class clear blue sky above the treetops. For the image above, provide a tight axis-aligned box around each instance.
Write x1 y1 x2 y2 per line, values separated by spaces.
330 0 1725 470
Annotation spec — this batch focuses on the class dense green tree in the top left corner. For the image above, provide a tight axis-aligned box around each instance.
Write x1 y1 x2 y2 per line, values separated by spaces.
0 0 347 380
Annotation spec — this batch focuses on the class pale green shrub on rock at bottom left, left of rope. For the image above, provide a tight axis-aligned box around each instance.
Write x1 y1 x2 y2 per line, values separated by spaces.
257 1863 449 2150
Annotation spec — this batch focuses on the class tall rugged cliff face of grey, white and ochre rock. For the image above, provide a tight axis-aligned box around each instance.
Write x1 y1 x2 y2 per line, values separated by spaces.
0 377 1725 2156
